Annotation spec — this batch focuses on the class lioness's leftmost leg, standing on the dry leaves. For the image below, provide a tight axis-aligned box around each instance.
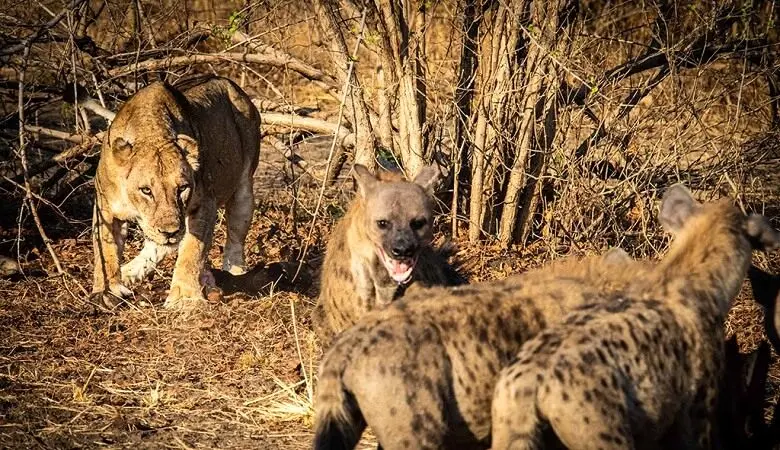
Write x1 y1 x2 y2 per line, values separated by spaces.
92 204 133 307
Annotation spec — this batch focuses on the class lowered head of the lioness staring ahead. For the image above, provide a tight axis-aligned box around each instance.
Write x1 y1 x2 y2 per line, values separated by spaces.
103 134 198 245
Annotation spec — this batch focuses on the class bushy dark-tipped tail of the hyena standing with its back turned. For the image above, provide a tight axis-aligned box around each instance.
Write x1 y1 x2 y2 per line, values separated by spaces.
314 374 366 450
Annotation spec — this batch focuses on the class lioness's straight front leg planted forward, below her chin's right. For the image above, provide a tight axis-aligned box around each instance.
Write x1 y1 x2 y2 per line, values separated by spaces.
164 198 217 309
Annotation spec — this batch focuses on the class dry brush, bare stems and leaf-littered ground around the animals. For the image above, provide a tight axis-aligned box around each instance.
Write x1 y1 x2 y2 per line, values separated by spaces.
0 0 780 448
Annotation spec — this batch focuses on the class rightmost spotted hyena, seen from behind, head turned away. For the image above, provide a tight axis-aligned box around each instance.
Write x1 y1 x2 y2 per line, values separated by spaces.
492 185 780 450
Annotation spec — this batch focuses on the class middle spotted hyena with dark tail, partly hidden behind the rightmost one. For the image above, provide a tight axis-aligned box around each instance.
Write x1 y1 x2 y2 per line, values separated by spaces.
314 246 644 450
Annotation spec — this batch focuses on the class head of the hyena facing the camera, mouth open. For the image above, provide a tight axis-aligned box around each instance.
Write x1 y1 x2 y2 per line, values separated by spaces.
353 164 440 283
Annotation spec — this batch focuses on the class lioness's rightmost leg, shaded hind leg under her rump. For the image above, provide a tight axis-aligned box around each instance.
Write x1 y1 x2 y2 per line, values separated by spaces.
222 169 255 275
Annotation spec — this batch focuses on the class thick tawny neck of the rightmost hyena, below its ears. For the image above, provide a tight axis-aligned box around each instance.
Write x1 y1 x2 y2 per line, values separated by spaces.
658 207 752 320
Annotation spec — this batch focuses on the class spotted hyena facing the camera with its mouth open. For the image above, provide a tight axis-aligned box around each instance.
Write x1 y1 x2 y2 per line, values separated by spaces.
313 164 463 347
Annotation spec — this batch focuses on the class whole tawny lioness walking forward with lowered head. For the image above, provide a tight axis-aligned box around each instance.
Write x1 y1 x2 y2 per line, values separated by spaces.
92 77 260 308
